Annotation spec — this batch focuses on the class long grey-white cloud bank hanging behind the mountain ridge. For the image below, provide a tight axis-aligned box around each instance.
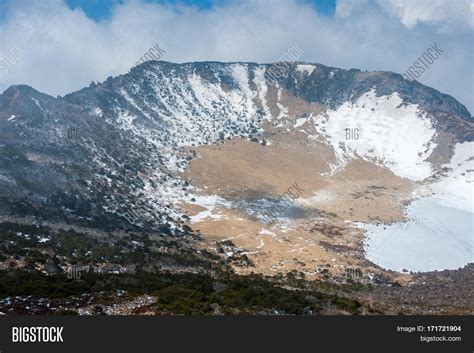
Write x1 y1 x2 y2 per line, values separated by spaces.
0 0 474 111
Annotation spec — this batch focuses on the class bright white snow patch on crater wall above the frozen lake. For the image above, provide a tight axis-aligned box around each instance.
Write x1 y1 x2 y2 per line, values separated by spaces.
315 89 436 181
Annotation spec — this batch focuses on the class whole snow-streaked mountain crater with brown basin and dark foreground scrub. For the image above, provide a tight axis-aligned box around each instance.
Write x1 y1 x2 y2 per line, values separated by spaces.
0 61 474 314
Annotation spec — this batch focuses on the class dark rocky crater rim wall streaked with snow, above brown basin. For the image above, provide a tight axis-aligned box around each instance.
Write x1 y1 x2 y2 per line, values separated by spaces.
0 62 474 233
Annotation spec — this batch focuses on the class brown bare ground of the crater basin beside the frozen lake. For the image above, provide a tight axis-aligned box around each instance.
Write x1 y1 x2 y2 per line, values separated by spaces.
182 128 416 282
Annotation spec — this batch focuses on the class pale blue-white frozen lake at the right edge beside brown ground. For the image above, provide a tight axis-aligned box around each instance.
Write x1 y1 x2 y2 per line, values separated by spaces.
359 197 474 272
